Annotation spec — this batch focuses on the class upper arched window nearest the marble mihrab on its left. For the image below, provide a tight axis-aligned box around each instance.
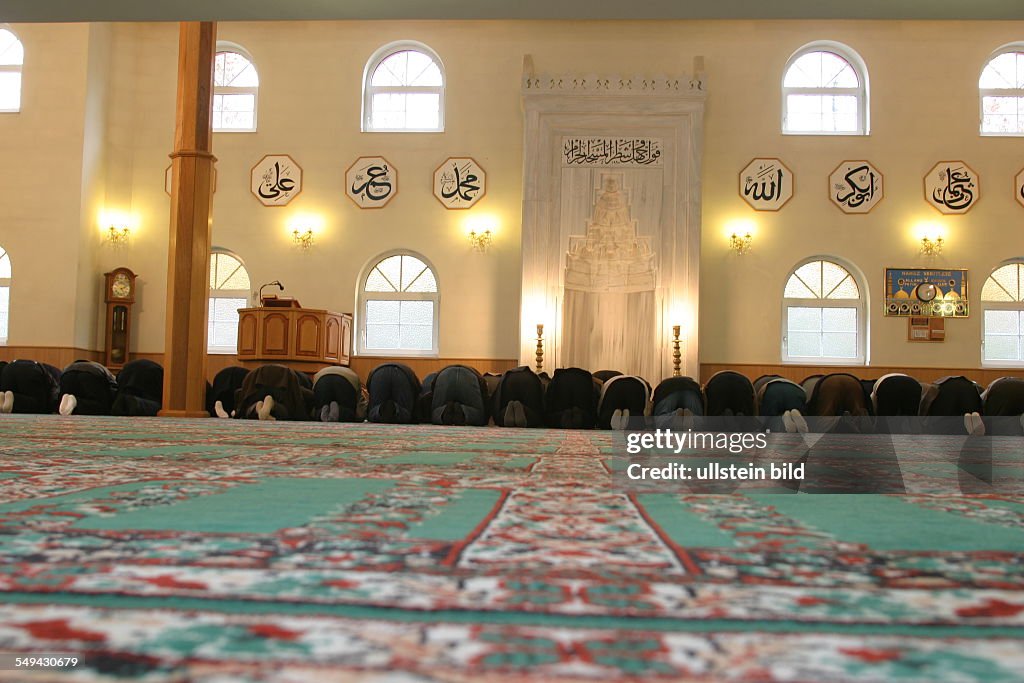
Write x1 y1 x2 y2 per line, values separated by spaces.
362 42 444 132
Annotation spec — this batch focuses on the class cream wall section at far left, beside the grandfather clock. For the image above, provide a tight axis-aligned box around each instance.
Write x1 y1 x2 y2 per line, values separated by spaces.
0 25 94 346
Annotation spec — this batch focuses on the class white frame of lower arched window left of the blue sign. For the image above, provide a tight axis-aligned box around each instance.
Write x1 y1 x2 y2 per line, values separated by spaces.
779 254 870 366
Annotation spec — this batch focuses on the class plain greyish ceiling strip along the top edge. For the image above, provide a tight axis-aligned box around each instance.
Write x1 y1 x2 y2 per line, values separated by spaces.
6 0 1024 22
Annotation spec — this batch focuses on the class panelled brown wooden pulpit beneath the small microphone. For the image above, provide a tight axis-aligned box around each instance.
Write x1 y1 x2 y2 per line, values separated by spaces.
238 299 352 372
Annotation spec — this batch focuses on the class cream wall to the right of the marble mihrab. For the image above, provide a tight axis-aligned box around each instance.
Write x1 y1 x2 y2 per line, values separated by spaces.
700 22 1024 367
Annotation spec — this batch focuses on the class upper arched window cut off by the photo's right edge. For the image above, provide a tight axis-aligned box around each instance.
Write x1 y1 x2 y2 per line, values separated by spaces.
978 43 1024 135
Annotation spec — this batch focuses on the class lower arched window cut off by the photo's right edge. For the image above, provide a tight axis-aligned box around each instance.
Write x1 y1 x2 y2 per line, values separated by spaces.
981 259 1024 366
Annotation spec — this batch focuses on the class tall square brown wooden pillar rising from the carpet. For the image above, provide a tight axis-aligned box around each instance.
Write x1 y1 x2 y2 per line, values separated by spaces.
160 22 217 417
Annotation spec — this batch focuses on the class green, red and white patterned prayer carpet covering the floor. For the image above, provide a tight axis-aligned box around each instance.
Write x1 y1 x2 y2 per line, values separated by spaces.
0 415 1024 683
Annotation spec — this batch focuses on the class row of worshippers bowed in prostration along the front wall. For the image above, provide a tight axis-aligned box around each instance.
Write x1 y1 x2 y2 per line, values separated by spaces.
0 359 1024 435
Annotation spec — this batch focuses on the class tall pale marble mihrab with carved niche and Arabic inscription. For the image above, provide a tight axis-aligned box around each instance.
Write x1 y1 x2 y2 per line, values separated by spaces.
520 57 705 384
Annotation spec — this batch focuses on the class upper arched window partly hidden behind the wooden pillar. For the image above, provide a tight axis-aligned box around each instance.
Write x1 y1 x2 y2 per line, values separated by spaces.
213 42 259 132
